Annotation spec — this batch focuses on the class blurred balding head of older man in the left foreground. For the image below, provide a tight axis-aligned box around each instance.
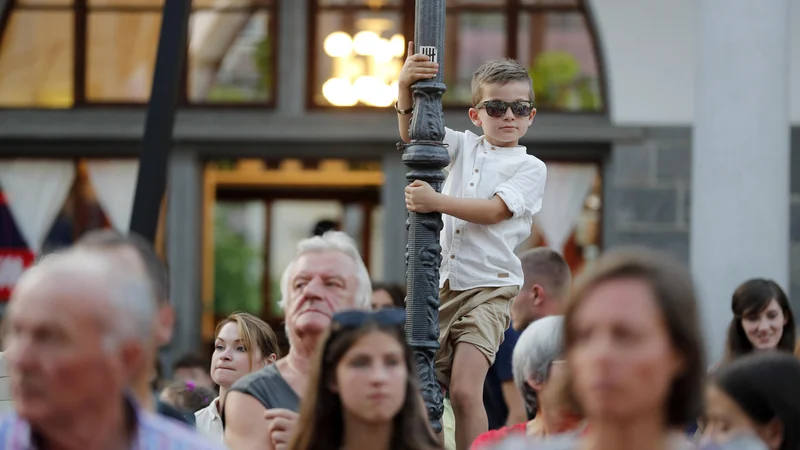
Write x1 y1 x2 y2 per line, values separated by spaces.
3 252 156 425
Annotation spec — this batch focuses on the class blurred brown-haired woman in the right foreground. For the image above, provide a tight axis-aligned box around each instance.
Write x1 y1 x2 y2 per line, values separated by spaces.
494 250 705 450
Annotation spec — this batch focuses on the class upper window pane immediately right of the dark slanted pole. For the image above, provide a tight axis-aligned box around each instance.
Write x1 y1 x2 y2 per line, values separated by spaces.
188 11 274 103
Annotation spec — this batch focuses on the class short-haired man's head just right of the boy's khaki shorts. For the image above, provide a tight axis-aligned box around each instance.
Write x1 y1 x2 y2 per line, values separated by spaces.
511 247 572 331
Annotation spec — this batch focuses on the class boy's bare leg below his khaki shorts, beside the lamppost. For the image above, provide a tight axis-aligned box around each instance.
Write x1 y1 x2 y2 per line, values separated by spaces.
450 342 489 450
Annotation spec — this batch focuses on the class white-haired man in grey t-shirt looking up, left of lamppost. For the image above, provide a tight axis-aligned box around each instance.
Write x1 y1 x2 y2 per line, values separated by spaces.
223 231 372 450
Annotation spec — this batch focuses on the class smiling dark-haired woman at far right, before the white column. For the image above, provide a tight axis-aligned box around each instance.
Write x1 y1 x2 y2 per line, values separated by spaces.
725 278 795 361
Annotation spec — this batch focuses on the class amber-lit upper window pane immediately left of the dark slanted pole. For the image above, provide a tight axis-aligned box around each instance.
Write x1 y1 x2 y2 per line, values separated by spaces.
86 12 161 102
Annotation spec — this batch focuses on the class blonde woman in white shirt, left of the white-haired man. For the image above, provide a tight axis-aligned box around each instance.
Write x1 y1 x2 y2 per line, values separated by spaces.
195 313 280 443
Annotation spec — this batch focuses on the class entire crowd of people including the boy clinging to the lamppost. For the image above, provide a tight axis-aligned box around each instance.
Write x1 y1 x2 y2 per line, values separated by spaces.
0 49 800 450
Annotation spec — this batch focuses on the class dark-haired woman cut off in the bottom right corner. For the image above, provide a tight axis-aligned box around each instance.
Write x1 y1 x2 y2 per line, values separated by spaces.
703 352 800 450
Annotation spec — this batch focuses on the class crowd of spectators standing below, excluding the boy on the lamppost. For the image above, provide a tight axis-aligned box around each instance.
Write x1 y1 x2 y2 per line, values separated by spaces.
0 232 800 450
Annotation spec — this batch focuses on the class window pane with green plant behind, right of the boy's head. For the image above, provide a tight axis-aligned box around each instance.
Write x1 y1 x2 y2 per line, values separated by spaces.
518 12 602 111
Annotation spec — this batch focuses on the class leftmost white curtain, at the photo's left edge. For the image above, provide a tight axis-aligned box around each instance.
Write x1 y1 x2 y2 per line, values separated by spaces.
0 159 75 254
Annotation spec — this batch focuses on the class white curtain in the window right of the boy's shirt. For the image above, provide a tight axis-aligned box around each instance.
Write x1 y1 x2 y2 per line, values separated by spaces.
534 163 597 252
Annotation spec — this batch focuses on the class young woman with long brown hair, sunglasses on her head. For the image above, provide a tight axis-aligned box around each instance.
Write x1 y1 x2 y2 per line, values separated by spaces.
289 308 439 450
